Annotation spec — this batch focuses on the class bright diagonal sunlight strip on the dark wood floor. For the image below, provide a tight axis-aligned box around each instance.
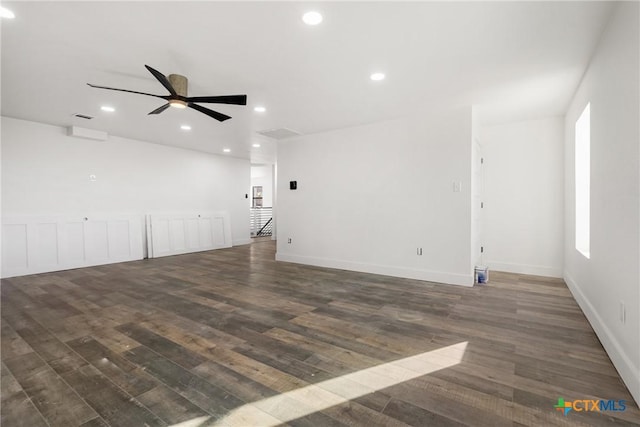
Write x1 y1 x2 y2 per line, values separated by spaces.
208 341 467 427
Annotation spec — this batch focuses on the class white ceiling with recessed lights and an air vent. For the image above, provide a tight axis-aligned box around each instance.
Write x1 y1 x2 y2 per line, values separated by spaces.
1 1 613 163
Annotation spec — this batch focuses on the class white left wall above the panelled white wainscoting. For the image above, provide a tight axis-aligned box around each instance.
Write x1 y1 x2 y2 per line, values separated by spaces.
1 117 250 244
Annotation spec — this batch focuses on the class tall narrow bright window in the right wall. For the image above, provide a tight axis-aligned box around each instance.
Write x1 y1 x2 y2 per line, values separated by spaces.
576 103 591 258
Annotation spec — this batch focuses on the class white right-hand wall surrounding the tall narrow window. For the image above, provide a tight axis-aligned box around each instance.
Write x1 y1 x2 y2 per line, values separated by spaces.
564 2 640 402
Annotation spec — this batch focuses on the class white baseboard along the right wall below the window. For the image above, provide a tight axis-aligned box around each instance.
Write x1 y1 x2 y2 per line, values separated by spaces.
564 271 640 404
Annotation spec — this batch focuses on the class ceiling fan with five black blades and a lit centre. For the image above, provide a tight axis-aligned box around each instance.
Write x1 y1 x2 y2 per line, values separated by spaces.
87 65 247 122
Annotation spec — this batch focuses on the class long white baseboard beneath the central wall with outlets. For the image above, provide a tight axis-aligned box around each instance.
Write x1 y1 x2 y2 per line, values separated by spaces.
276 252 473 286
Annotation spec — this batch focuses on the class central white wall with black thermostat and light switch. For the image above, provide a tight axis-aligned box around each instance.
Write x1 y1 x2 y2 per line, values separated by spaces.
277 108 473 286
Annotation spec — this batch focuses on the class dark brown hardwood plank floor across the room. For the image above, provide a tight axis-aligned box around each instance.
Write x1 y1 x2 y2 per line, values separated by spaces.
1 241 640 427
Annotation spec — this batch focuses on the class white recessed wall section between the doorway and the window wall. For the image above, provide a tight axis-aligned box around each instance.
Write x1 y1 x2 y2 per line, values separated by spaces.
480 117 564 277
